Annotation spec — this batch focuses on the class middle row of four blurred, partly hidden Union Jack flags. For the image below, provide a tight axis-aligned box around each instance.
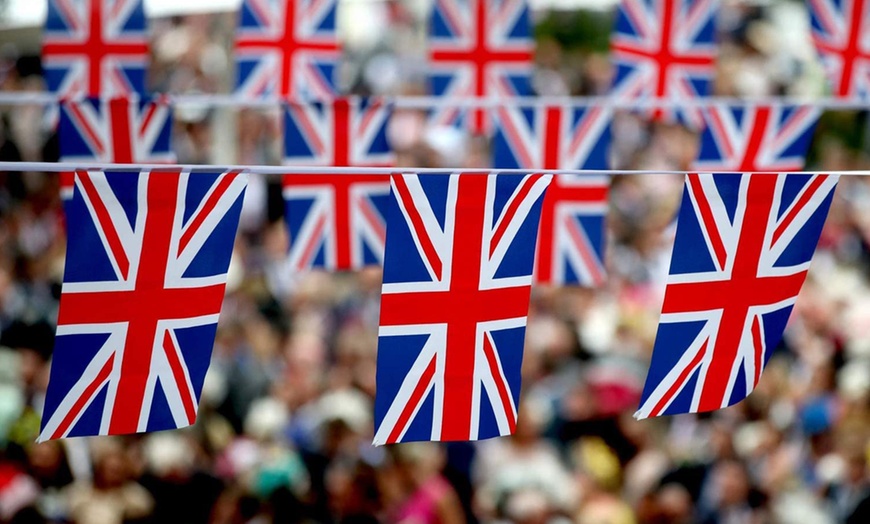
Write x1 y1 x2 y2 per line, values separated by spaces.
59 98 819 286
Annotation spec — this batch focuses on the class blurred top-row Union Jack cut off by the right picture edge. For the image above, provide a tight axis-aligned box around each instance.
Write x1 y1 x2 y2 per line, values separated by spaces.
807 0 870 99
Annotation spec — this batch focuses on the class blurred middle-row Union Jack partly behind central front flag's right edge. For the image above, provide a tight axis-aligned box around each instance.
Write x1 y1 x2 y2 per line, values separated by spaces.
492 105 613 286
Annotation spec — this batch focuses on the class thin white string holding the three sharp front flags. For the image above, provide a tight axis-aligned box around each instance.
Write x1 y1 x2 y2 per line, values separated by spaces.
0 162 870 176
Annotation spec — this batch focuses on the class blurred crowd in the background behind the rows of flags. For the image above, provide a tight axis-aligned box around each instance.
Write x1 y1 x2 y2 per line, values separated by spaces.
0 0 870 524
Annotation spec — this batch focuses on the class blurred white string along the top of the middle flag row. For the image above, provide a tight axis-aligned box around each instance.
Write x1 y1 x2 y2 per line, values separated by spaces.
0 91 870 110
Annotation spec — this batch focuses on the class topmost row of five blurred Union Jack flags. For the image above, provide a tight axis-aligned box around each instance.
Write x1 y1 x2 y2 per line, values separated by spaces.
42 0 870 110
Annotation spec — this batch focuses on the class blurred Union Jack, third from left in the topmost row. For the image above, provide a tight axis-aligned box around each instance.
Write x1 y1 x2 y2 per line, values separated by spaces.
429 0 534 133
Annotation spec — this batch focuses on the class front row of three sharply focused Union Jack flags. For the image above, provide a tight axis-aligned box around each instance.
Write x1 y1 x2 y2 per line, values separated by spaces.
40 166 838 444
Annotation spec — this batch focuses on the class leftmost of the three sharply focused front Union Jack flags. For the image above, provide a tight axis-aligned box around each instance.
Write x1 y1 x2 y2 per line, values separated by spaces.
39 171 247 441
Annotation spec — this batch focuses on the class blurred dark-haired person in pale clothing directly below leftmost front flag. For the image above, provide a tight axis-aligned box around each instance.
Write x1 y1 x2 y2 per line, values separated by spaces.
65 437 154 524
